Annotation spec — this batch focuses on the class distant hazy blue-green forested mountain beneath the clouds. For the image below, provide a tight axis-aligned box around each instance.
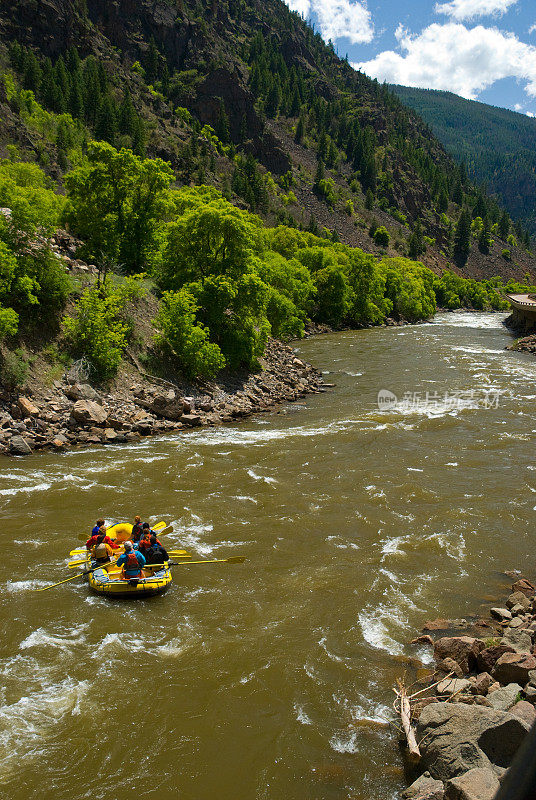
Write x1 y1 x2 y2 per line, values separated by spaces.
391 86 536 234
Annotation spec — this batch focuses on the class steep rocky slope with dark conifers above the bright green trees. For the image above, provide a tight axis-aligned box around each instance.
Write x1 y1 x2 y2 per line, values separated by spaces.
0 0 534 278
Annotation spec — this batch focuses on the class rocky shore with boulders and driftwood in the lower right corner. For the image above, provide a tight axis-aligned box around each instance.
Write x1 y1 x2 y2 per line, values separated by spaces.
402 573 536 800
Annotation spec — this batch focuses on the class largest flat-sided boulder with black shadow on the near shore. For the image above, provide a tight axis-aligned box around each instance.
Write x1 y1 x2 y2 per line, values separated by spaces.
417 703 530 781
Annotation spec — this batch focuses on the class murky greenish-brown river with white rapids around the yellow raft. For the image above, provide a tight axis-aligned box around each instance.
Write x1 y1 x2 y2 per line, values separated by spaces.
0 313 536 800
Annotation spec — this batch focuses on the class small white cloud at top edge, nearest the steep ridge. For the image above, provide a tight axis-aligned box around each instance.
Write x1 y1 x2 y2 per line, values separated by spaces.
286 0 374 44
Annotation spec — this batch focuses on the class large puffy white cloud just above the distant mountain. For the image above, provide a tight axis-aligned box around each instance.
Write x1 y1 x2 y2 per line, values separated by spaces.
353 22 536 99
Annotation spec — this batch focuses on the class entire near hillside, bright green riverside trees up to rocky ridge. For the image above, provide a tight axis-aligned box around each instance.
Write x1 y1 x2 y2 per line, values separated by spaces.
0 0 535 396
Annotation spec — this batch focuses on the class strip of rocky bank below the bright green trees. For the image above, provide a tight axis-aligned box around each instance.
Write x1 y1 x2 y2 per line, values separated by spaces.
0 339 330 456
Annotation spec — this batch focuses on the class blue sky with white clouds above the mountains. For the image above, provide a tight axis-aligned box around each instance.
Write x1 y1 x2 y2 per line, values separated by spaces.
286 0 536 116
